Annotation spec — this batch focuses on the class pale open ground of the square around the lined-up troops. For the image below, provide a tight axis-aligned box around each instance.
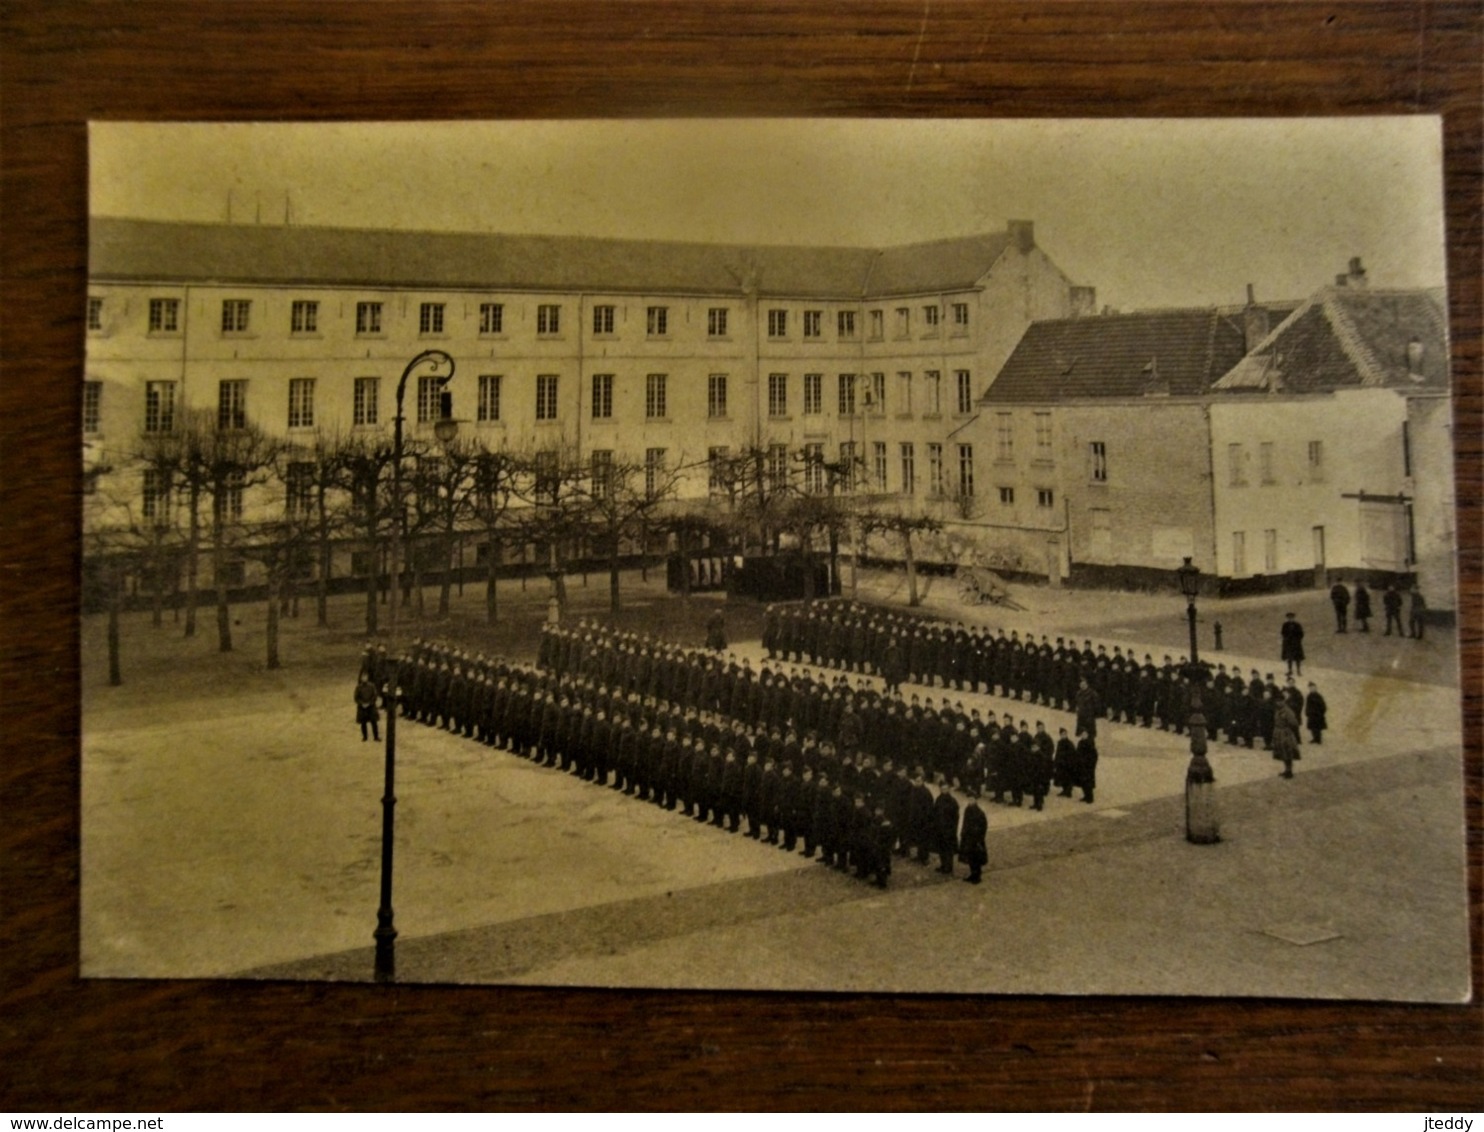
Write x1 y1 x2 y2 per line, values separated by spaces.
82 574 1468 1001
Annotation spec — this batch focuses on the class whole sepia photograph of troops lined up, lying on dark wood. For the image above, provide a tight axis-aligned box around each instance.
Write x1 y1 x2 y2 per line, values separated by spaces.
84 116 1472 1003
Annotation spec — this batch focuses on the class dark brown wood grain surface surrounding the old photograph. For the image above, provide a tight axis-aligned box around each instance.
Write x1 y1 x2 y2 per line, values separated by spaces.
0 0 1484 1111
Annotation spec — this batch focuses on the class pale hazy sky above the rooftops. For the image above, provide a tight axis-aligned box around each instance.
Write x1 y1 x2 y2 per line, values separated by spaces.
89 116 1445 310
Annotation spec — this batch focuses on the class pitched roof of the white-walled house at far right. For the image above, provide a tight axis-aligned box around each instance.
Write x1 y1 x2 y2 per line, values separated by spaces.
1214 286 1448 393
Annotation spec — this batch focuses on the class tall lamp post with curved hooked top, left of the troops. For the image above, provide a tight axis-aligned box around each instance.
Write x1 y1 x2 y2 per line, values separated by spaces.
372 350 459 982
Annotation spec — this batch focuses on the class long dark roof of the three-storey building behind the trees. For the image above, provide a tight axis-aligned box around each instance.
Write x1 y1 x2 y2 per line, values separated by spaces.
89 217 1012 300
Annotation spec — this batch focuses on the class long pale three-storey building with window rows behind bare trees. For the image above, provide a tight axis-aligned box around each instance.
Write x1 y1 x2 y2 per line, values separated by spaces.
83 218 1094 584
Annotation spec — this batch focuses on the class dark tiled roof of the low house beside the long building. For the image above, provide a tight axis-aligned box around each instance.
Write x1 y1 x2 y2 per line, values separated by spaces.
985 306 1288 401
